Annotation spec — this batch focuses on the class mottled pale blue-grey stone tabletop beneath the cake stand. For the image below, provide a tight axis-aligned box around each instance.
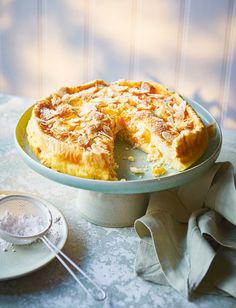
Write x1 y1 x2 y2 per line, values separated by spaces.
0 95 236 308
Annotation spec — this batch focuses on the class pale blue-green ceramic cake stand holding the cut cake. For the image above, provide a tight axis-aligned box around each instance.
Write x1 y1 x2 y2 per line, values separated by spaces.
15 99 222 227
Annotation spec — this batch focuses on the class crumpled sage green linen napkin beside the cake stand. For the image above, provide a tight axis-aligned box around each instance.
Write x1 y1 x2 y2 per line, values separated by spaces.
135 162 236 299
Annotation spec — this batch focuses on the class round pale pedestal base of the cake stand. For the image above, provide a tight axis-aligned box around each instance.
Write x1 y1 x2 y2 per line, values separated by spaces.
77 189 149 228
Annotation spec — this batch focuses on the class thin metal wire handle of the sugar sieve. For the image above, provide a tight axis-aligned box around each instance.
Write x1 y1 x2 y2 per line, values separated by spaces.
41 235 106 301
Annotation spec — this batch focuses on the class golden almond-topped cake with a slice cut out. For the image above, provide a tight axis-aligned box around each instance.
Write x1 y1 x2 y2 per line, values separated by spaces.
27 80 208 180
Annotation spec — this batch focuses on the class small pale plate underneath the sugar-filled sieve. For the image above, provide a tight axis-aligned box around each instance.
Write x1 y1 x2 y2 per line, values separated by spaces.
0 191 68 281
